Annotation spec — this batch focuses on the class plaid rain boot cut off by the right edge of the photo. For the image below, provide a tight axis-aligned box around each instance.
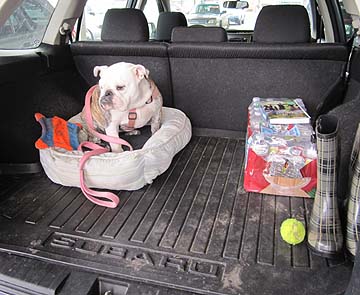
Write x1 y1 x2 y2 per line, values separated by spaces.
345 125 360 256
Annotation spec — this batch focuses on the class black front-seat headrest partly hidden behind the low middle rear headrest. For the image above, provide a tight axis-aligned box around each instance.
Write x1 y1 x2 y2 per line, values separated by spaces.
156 12 187 41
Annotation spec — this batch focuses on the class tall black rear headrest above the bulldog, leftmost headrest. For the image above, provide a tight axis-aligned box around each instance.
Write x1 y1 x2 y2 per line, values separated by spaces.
101 8 149 42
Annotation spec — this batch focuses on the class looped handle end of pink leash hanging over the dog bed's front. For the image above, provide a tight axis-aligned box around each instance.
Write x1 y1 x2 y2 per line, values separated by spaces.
78 141 119 208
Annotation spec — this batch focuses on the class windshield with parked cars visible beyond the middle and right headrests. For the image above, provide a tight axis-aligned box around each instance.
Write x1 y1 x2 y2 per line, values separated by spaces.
170 0 315 35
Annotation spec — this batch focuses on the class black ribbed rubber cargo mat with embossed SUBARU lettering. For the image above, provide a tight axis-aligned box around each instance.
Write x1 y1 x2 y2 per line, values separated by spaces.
0 136 351 295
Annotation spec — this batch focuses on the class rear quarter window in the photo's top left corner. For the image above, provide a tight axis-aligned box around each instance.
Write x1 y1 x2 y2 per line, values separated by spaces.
0 0 57 49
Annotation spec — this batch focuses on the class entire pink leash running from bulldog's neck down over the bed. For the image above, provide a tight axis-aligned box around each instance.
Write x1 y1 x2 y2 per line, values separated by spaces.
78 85 133 208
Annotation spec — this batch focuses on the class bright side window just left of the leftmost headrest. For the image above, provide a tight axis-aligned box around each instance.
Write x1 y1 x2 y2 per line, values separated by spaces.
77 0 127 41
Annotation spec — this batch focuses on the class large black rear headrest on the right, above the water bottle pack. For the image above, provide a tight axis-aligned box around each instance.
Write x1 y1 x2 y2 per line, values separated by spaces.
254 5 310 43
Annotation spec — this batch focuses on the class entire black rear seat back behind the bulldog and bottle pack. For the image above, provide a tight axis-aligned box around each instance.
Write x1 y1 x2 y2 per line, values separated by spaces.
71 6 347 131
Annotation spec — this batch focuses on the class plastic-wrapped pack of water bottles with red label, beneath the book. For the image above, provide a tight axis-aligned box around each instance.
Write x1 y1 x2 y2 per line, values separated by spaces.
244 98 317 198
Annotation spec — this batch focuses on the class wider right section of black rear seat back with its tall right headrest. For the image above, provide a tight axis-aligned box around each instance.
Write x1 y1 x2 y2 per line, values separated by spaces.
168 6 347 131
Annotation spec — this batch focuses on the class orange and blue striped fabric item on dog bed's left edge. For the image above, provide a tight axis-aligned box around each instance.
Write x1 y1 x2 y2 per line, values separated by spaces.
35 113 81 151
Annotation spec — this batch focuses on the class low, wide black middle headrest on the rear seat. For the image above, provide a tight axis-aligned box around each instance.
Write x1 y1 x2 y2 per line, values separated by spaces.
171 27 227 42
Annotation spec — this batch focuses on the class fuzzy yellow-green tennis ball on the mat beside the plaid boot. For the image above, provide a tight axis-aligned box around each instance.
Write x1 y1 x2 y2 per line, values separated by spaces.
280 218 305 245
